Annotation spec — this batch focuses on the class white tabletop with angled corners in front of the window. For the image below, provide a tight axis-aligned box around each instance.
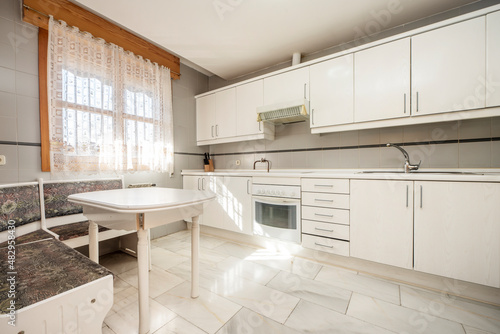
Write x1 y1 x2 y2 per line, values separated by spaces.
68 187 215 213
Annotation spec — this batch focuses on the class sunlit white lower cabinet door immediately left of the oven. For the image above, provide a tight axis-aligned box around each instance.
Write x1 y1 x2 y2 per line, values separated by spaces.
222 177 253 235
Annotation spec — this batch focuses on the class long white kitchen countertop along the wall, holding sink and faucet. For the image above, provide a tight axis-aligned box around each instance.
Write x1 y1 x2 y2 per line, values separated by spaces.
181 168 500 182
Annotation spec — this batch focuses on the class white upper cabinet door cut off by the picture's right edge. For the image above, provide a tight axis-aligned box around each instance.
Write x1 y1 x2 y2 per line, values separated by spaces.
486 11 500 107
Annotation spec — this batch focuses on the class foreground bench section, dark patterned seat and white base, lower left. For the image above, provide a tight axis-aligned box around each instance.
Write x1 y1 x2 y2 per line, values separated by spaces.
0 239 113 334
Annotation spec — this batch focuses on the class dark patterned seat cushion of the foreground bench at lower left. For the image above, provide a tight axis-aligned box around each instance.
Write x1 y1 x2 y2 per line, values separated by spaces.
0 239 112 314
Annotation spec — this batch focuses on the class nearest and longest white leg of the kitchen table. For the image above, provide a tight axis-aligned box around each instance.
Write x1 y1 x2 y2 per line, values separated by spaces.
137 228 149 334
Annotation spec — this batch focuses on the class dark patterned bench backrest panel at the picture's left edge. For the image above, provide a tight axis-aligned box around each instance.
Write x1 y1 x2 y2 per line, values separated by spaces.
0 184 40 232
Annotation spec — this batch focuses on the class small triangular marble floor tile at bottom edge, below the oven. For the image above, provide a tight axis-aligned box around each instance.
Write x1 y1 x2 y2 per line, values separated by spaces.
217 307 300 334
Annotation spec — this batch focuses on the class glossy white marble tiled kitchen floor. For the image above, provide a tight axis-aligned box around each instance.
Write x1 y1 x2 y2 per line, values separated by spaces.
101 231 500 334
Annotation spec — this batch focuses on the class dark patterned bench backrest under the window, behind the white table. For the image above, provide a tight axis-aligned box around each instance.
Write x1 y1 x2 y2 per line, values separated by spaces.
43 180 122 218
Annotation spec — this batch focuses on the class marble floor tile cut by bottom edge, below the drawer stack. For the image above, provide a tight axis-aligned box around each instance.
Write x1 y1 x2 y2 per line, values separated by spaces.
285 300 393 334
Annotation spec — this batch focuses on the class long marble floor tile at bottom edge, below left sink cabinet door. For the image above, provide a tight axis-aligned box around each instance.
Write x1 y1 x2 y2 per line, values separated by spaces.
347 293 465 334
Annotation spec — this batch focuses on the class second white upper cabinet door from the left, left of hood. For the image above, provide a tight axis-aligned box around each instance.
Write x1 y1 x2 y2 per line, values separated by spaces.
215 88 236 138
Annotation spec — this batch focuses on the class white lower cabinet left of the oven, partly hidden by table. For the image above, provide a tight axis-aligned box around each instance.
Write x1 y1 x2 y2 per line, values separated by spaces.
183 176 252 235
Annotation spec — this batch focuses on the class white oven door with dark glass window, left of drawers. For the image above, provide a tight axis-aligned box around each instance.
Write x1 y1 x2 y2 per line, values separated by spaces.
252 196 301 243
